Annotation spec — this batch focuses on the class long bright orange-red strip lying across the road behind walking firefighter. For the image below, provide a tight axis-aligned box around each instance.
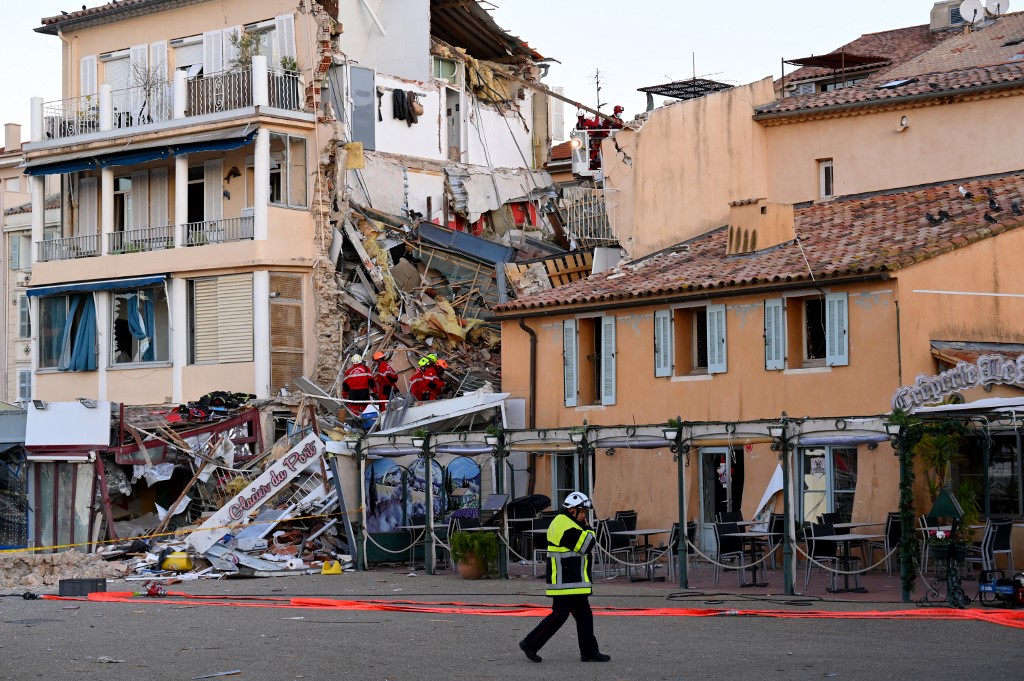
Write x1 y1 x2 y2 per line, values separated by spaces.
42 591 1024 629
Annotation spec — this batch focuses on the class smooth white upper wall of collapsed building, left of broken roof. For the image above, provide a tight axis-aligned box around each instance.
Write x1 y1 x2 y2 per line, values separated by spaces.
339 0 432 81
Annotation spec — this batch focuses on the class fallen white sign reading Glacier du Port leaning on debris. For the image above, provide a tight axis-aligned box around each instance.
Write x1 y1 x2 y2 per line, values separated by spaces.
185 433 324 553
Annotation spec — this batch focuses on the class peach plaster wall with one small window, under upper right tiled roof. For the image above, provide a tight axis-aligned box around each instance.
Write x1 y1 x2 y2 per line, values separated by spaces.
763 94 1024 203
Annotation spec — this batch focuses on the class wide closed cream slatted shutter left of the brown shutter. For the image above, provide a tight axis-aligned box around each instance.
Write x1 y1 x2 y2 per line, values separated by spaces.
193 274 253 364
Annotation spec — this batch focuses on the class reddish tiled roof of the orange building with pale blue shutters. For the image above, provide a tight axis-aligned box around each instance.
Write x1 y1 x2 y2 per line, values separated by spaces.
497 170 1024 311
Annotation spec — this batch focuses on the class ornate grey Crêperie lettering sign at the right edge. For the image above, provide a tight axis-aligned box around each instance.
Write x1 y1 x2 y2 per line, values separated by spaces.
892 354 1024 412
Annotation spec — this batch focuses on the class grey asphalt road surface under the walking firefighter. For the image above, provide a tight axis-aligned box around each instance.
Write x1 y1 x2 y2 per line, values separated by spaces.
0 568 1024 681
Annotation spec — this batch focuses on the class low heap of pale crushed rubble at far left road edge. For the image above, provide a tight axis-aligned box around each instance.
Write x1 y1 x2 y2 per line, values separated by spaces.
0 551 128 589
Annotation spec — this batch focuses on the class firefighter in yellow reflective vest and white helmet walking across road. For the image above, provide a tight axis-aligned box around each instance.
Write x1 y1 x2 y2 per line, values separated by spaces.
519 492 611 663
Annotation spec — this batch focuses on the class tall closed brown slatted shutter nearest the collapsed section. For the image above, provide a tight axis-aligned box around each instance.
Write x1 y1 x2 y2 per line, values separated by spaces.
270 272 304 394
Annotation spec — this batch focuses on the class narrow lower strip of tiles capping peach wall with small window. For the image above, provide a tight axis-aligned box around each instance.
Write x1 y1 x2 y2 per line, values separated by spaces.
755 61 1024 119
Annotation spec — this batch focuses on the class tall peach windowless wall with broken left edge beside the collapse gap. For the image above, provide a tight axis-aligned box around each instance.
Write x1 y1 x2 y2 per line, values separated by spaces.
602 78 774 258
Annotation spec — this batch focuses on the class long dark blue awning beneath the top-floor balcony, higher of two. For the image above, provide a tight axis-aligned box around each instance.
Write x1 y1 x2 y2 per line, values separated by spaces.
25 125 256 175
